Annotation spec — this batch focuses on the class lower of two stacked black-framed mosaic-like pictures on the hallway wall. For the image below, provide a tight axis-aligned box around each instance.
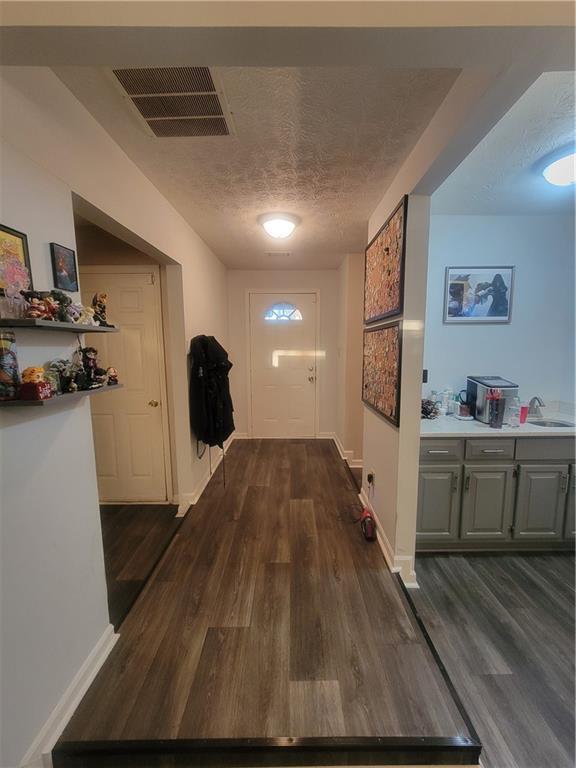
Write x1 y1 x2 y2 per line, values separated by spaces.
362 320 402 427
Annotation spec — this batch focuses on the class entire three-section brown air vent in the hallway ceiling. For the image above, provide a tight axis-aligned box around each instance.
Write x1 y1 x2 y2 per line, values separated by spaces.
112 67 234 138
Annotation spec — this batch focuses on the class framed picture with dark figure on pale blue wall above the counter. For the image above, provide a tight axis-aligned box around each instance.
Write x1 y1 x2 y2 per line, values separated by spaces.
444 267 514 323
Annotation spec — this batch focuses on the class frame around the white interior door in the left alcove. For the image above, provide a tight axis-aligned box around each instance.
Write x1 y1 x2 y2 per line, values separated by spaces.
78 264 175 504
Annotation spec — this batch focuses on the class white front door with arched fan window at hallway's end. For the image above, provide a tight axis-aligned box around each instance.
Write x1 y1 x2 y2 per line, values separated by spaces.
250 293 316 437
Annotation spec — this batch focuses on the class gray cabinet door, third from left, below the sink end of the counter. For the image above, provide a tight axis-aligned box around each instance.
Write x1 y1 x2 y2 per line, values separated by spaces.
514 464 568 539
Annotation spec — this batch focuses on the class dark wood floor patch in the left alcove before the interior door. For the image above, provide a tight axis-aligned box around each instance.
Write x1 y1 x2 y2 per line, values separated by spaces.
100 504 182 630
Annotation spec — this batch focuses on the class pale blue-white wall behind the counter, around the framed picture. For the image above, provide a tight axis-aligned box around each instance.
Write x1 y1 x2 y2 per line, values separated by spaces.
423 210 574 402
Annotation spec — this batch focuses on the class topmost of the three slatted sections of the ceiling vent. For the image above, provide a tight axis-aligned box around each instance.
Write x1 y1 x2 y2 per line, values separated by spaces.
113 67 216 96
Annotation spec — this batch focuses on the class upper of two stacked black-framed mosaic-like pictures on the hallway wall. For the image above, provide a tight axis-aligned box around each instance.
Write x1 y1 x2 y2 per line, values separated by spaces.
364 195 408 324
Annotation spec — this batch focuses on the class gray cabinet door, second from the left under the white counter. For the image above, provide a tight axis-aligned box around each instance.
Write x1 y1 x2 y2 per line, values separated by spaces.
460 464 515 541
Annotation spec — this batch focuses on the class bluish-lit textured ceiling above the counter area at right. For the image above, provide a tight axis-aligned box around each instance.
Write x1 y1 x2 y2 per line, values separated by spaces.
432 72 575 214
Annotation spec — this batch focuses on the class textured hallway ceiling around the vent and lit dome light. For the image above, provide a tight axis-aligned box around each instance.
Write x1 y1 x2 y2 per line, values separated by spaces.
55 67 458 269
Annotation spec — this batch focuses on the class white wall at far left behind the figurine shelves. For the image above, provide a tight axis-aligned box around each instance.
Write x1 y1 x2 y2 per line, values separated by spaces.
0 144 108 766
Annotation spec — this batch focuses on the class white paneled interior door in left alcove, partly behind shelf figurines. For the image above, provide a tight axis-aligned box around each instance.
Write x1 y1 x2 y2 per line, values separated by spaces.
80 267 167 502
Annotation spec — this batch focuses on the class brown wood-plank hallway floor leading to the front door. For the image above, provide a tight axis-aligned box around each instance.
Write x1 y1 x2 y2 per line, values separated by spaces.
55 440 469 765
